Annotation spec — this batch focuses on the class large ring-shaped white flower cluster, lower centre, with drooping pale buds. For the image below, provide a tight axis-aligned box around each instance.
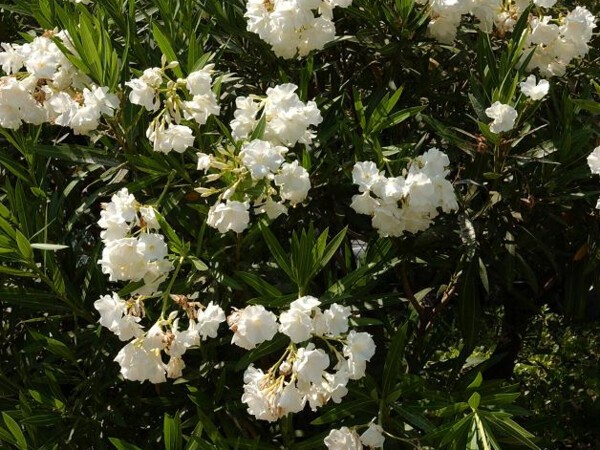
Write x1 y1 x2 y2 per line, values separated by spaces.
227 296 375 421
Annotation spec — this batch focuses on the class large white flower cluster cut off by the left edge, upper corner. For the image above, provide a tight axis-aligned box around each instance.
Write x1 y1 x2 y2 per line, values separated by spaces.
0 31 119 134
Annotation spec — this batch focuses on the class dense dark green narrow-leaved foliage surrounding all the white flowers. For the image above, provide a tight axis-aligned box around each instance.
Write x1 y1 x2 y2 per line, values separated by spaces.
0 0 600 449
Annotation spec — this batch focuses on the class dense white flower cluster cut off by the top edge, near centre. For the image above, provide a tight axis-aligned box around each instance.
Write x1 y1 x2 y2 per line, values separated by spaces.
244 0 352 59
